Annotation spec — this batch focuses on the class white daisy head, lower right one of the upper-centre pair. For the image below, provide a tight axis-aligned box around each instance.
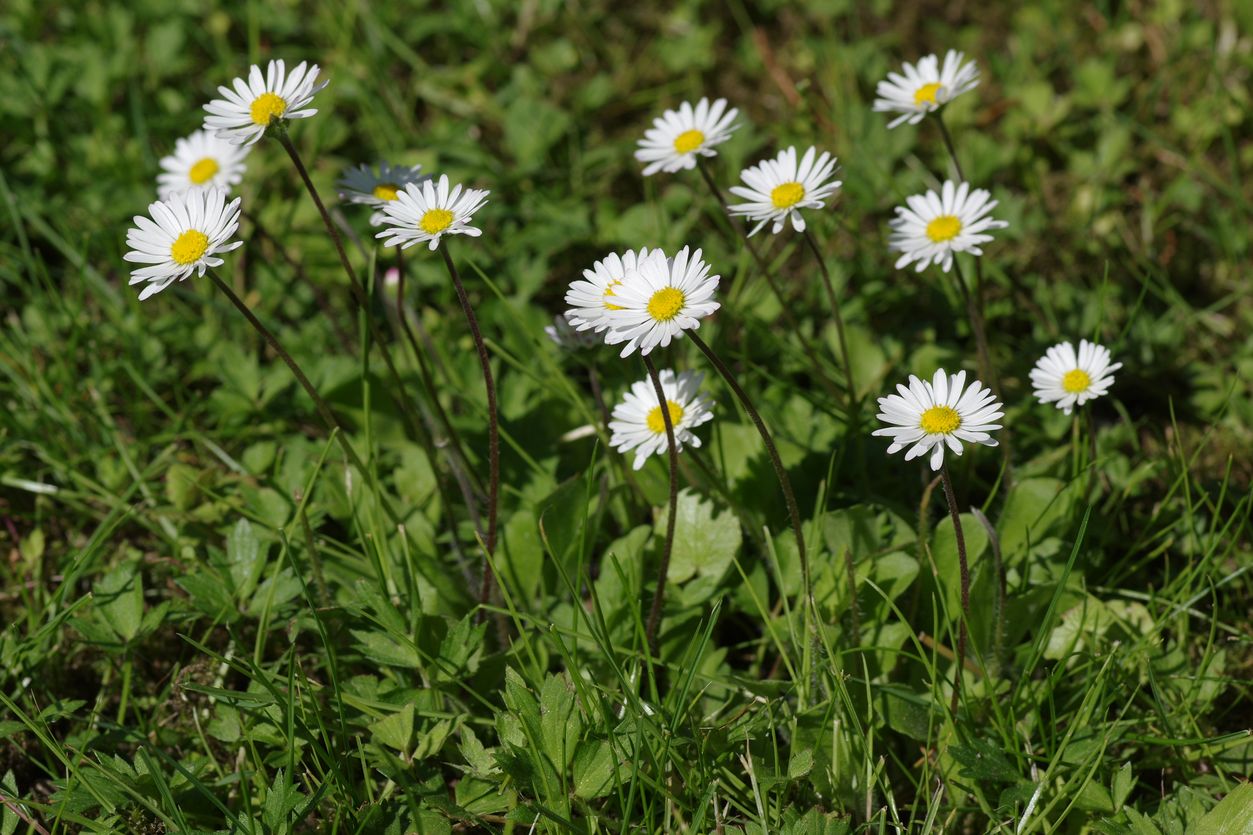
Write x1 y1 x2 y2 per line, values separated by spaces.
729 147 843 237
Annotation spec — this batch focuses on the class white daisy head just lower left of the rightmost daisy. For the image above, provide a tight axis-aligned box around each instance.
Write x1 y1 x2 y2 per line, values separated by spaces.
872 369 1005 470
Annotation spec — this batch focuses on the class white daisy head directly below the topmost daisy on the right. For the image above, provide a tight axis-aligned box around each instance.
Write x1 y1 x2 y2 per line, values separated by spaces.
888 179 1009 272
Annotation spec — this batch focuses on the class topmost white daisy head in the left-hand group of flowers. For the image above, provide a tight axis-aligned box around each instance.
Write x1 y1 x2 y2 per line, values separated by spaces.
204 60 330 145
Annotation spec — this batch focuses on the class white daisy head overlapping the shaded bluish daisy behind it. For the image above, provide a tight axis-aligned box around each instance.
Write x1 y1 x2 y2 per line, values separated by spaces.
375 174 489 251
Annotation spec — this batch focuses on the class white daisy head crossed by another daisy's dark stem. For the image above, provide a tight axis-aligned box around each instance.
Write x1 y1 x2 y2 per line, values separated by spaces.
609 369 713 470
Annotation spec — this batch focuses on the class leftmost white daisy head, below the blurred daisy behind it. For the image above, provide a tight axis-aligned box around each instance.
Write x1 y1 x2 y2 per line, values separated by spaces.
123 188 243 301
